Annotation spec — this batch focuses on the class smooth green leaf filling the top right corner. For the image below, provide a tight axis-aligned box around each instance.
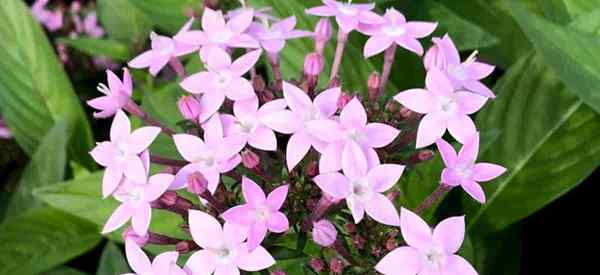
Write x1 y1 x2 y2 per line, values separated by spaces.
512 0 600 112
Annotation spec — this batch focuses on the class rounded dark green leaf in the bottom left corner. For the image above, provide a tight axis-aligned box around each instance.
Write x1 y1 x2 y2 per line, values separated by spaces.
0 207 101 275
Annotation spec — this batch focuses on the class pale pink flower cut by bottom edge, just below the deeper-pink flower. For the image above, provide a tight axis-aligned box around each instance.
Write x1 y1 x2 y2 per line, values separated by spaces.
185 210 275 275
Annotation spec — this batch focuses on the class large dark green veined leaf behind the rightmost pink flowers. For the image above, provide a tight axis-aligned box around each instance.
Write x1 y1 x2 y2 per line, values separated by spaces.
466 55 600 231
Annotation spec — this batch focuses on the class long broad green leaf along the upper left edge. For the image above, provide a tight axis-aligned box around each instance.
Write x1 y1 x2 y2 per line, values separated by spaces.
0 0 93 167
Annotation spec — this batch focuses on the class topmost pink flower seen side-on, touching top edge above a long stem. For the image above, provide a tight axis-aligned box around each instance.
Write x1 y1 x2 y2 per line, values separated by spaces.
306 0 383 33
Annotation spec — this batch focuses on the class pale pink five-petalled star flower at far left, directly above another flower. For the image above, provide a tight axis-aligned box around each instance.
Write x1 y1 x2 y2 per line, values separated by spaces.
90 111 160 198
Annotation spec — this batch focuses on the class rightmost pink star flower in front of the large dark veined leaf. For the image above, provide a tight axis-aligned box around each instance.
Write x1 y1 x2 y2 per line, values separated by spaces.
436 133 506 203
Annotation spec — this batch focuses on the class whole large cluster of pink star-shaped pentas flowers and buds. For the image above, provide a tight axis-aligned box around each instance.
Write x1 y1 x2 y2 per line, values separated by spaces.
88 0 505 275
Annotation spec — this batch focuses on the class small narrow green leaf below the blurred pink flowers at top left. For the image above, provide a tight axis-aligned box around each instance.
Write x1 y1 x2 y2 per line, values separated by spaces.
58 37 131 61
